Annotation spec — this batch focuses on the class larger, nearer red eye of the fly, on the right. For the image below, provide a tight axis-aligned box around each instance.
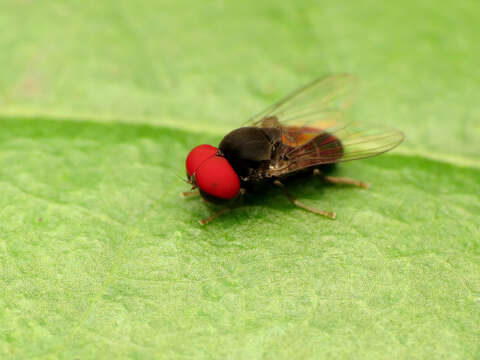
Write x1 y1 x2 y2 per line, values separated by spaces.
195 156 240 199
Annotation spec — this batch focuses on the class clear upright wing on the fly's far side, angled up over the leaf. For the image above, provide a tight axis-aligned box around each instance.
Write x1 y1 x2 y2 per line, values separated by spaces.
248 74 356 128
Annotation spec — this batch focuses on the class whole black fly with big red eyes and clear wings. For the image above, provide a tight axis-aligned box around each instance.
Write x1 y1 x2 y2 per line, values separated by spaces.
182 74 404 225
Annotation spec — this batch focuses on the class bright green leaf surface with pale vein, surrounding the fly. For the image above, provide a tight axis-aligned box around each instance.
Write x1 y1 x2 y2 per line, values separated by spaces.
0 0 480 359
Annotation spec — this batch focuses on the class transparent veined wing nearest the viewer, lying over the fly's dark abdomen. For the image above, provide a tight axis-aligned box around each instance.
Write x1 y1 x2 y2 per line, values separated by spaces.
271 121 404 175
